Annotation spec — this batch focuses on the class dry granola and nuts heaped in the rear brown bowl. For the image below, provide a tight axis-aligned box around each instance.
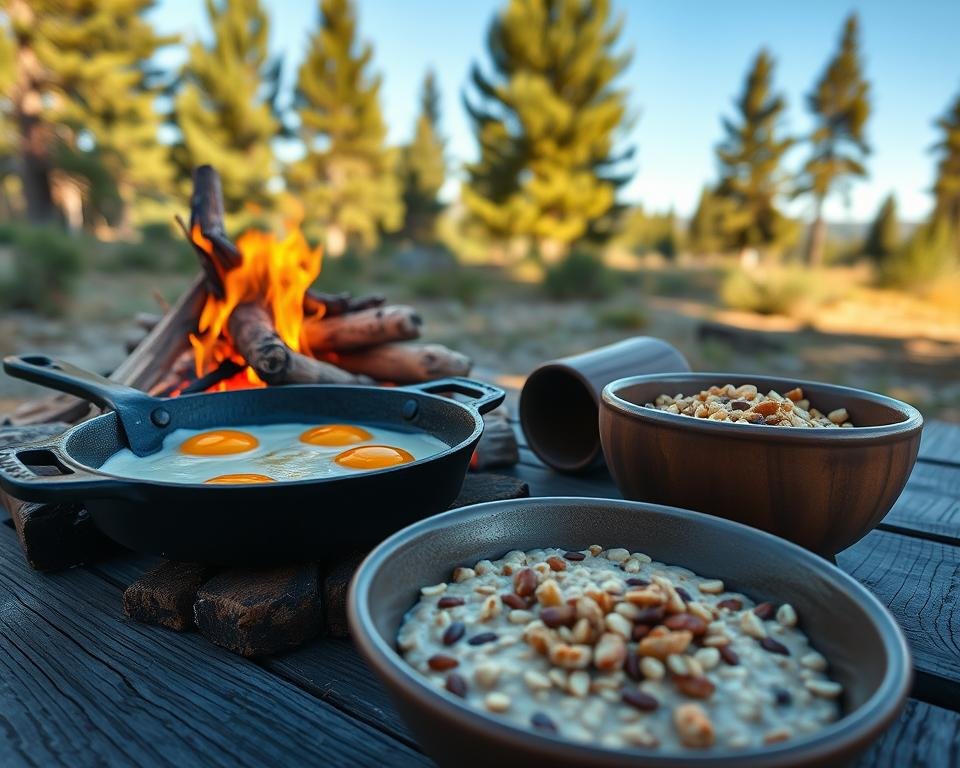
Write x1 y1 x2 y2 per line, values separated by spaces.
645 384 854 428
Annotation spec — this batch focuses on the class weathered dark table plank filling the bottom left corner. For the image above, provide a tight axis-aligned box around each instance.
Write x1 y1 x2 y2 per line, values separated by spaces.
0 526 429 768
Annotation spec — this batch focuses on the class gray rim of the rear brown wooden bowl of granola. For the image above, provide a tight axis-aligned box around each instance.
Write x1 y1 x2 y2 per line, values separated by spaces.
600 372 923 443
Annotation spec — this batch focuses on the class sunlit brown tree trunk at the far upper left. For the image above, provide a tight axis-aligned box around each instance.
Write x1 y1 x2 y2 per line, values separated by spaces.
8 0 56 222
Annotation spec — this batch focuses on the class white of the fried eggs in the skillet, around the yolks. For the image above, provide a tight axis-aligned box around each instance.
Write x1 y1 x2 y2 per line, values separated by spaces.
100 422 449 483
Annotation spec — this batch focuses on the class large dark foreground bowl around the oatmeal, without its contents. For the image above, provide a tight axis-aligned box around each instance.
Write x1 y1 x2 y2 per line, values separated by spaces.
348 498 911 768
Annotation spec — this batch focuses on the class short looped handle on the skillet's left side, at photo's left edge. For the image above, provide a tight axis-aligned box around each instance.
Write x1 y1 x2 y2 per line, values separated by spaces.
0 442 116 502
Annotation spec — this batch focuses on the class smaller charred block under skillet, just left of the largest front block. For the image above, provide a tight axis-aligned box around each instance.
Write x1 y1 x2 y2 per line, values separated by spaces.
123 560 215 632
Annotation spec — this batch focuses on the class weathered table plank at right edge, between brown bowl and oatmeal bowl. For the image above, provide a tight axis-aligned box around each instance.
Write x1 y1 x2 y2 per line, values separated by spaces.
837 531 960 709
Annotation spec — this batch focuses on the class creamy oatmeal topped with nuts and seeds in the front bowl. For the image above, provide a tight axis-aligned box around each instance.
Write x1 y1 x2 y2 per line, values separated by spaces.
397 545 843 751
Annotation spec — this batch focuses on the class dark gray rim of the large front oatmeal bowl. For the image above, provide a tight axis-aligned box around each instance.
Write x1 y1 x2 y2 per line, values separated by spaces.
347 496 913 768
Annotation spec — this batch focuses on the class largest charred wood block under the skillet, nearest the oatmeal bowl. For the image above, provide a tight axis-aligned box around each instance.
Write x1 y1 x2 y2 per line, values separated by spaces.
194 563 323 656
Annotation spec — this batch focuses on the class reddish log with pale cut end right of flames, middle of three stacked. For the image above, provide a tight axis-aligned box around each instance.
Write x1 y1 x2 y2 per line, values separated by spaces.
303 306 423 354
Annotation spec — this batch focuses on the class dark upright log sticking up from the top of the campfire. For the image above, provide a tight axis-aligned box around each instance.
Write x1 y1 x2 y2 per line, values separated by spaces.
188 165 242 299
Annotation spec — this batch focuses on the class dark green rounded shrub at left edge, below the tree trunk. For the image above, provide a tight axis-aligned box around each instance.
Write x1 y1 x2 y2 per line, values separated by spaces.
0 227 82 315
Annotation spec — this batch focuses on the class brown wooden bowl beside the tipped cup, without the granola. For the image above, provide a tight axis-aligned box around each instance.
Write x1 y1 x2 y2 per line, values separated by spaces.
600 373 923 558
